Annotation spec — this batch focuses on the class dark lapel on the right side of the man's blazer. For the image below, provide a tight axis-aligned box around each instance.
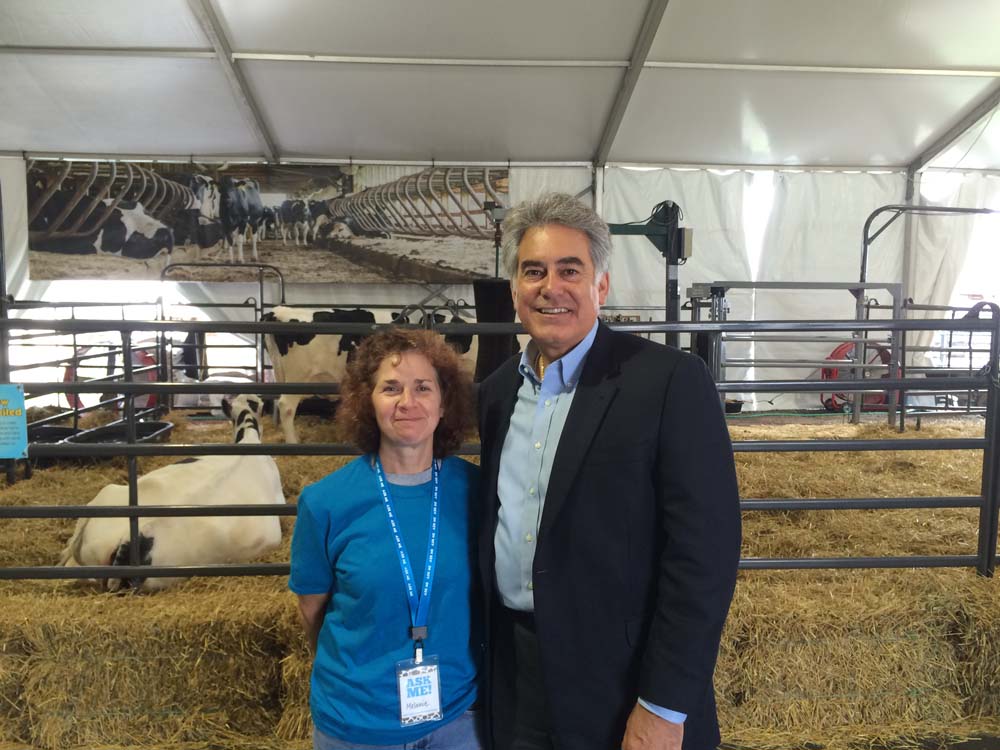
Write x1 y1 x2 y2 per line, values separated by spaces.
538 324 618 539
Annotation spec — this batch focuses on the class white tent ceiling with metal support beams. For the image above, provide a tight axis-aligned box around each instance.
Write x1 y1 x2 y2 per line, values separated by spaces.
0 0 1000 169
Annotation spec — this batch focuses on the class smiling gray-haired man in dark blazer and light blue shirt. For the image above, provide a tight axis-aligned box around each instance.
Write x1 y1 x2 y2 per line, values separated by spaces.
479 194 740 750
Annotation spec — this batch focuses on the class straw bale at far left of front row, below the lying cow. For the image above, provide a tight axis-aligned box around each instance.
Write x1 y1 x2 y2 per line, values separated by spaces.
0 589 285 748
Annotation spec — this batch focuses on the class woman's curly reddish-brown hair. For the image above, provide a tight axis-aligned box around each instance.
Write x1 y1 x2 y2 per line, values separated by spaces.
336 328 472 458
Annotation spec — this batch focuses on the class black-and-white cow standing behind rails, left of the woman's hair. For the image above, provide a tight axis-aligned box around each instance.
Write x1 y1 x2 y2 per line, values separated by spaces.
261 307 375 443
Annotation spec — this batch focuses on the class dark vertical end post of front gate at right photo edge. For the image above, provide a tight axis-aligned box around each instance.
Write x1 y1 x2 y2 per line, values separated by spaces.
976 314 1000 576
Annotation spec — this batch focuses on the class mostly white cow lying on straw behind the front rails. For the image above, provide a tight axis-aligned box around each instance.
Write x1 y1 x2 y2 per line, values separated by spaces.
59 396 285 591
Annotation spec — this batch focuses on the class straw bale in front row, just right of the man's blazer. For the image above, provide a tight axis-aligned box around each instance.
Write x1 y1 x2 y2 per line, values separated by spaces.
717 571 972 746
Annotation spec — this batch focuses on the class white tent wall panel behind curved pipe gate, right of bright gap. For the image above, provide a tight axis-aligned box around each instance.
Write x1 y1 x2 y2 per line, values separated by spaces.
754 172 906 408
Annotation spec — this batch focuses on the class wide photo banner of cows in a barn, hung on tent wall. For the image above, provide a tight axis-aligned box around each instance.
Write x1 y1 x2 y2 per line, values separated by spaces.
27 161 509 284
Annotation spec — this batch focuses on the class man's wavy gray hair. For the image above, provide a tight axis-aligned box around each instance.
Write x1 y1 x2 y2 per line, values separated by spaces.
500 193 611 282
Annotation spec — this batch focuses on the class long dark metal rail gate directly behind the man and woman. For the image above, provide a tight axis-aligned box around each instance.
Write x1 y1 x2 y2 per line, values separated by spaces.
0 306 1000 579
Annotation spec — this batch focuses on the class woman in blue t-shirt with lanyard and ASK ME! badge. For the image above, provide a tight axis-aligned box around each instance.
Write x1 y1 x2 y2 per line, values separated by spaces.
289 328 481 750
